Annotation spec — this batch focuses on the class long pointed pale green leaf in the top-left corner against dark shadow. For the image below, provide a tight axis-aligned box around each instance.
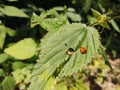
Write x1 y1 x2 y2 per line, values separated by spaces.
0 5 28 18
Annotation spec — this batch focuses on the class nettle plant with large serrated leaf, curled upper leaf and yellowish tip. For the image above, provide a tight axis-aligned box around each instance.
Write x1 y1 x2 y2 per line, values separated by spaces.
28 9 115 90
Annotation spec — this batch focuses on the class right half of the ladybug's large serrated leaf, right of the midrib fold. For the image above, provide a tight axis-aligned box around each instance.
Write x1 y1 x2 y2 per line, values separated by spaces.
60 27 100 77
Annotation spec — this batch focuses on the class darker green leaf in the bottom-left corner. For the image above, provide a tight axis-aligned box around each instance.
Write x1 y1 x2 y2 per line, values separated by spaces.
2 76 15 90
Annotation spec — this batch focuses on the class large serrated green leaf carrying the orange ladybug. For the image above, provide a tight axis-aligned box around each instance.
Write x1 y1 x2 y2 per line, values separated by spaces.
30 23 101 90
